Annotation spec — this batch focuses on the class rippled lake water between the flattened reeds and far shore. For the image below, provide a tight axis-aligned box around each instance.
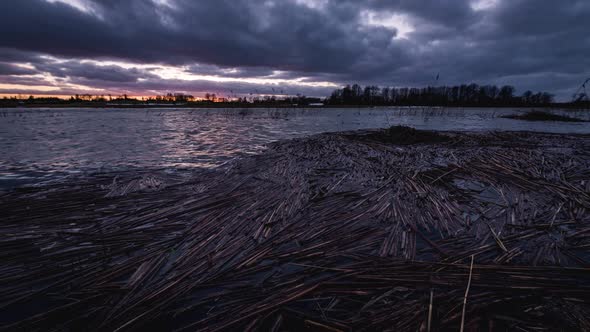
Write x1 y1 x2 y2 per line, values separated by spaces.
0 108 590 188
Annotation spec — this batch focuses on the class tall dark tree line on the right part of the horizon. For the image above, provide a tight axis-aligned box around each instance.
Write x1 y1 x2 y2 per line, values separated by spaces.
327 84 553 106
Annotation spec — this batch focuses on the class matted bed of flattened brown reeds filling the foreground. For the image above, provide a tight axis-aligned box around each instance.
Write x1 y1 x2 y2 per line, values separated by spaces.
0 128 590 331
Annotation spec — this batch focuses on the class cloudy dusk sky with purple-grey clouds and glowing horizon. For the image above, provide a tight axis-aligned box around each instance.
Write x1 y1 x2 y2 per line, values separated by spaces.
0 0 590 100
